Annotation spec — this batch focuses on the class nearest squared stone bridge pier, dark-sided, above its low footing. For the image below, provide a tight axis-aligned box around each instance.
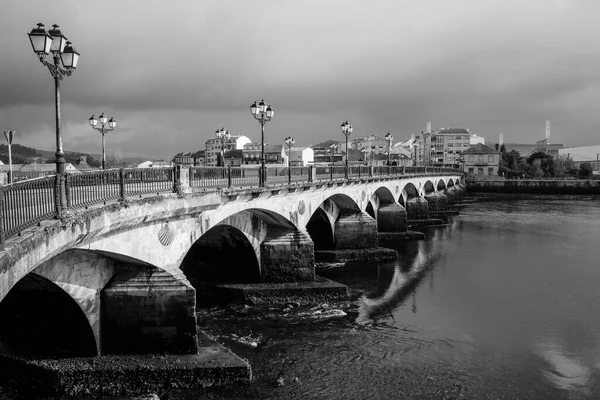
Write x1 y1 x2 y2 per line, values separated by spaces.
101 267 198 354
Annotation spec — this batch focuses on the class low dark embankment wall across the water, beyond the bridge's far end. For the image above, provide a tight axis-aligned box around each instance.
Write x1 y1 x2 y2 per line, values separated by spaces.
467 179 600 194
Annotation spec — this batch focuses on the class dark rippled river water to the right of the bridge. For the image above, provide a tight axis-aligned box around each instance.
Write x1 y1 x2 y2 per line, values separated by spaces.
192 197 600 399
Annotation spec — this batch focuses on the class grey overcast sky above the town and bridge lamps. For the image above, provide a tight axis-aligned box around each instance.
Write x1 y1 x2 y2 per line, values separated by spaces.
0 0 600 158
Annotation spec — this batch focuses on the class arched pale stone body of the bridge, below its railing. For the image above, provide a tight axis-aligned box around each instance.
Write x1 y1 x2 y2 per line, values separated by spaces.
0 173 464 355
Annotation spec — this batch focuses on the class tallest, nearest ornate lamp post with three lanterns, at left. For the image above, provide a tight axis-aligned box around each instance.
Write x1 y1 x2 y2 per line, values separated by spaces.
28 23 80 216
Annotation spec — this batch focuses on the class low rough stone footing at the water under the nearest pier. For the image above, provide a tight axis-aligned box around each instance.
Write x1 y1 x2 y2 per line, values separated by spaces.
0 332 252 398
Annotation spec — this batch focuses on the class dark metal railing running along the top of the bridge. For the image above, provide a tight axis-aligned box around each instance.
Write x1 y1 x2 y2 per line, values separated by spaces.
0 165 462 249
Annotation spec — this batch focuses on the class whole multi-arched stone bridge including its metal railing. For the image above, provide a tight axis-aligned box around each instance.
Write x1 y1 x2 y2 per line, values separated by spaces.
0 167 464 354
